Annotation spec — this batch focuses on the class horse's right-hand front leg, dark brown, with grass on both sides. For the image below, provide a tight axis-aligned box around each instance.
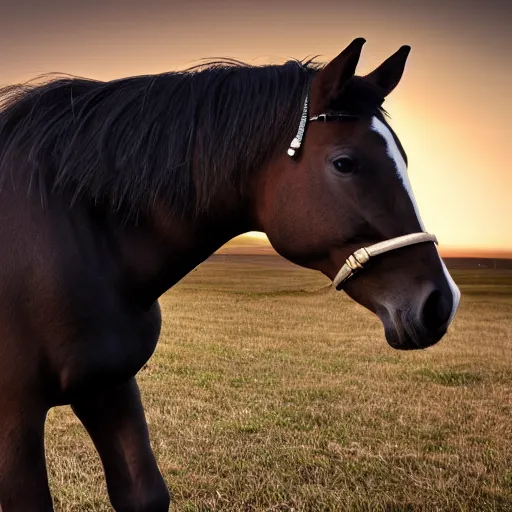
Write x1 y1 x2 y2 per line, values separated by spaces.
71 377 170 512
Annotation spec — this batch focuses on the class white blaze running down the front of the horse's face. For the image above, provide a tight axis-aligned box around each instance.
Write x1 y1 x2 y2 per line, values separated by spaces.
371 117 460 324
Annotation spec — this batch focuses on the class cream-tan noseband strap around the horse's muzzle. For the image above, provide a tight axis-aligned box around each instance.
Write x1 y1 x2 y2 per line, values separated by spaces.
332 233 437 290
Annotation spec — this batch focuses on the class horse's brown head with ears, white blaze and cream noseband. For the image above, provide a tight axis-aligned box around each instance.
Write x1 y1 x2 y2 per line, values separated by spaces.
256 39 460 349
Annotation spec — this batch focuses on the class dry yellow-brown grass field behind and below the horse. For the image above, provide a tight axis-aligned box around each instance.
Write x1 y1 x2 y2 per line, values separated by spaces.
47 256 512 512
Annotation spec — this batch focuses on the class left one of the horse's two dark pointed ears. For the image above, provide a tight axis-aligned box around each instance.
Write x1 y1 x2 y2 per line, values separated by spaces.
312 37 366 105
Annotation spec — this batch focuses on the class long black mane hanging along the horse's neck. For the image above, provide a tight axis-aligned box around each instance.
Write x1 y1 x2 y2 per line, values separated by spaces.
0 61 384 216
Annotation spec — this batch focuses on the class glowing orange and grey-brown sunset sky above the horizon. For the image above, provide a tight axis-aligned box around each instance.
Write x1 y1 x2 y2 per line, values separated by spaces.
0 0 512 256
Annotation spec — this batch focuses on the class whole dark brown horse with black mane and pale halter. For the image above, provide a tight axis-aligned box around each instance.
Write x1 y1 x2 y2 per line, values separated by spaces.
0 38 460 512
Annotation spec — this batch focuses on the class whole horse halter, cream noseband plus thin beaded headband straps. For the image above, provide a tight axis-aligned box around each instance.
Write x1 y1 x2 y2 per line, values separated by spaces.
288 95 438 290
